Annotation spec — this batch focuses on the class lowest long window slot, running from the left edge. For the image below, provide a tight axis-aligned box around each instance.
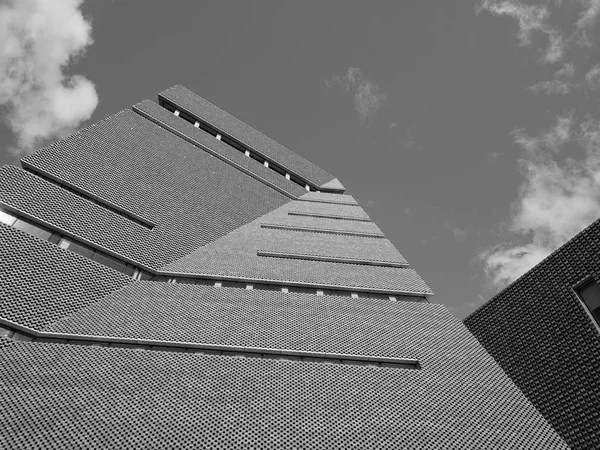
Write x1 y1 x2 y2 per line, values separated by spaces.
0 321 421 370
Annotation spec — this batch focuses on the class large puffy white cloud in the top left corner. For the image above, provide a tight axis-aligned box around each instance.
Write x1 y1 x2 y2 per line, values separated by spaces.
0 0 98 153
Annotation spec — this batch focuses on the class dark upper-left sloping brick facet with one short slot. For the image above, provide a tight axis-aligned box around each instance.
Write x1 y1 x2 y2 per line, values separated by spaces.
19 111 289 268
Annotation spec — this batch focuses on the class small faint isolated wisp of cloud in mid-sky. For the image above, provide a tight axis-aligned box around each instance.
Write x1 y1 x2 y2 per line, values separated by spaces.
325 67 387 126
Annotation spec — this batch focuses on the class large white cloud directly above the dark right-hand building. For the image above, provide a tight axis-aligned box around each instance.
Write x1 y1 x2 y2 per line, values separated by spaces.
480 114 600 286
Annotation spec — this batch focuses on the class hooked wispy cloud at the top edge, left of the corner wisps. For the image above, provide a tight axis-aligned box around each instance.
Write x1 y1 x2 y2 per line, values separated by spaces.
476 0 566 63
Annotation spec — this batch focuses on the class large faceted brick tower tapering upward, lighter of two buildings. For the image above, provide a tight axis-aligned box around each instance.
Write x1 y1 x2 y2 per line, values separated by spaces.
0 86 567 449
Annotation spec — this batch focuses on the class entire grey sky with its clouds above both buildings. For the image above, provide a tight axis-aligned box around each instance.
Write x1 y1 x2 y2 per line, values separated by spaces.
0 0 600 317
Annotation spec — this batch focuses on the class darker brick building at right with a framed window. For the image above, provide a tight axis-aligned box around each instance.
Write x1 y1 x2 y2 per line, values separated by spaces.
464 220 600 449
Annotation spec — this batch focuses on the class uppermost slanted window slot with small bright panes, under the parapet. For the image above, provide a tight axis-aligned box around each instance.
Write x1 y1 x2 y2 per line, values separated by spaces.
159 98 318 194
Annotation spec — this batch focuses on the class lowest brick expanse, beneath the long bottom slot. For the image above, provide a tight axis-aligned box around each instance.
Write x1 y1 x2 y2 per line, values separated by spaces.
0 324 567 450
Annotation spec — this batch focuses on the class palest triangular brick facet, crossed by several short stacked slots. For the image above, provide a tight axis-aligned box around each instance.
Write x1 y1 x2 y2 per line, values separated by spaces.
162 200 431 295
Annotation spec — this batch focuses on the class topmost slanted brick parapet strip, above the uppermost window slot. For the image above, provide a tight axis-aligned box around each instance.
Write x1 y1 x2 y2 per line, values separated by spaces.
159 85 334 186
